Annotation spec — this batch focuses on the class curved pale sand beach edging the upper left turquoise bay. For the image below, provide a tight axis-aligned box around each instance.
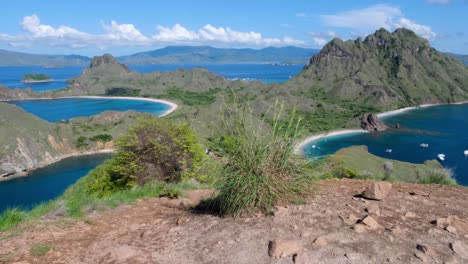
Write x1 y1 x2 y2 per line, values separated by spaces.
0 95 179 117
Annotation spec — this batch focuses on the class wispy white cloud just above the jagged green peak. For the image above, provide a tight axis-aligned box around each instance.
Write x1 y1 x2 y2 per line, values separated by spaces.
321 4 436 40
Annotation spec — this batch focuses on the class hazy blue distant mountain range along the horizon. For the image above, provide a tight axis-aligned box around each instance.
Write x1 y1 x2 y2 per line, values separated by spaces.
0 46 468 67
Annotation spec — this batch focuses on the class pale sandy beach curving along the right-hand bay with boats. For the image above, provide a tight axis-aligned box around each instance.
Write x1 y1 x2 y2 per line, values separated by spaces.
294 101 468 154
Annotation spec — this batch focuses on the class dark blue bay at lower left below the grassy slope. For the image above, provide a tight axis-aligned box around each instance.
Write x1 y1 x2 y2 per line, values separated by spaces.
0 154 111 213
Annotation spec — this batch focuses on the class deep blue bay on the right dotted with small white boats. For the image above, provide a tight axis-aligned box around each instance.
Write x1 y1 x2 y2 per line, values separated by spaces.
304 104 468 186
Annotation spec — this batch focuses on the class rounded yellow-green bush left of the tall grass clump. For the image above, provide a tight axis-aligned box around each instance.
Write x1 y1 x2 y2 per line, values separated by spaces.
88 118 205 195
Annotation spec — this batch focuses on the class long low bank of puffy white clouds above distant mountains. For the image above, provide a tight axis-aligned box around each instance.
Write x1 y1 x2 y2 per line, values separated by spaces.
0 14 305 48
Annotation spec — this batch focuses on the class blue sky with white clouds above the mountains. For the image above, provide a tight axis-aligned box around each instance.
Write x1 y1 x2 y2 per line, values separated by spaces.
0 0 468 56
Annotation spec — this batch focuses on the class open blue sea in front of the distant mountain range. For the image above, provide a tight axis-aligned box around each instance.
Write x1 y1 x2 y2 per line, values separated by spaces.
0 64 304 92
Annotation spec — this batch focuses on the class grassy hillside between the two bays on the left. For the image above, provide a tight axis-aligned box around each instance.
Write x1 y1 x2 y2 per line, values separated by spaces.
0 103 154 175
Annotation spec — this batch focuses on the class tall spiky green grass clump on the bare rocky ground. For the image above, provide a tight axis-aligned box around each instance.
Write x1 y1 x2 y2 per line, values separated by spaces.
211 101 313 216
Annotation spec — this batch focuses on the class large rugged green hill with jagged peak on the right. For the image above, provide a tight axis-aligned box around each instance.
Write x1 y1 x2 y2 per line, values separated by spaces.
288 29 468 110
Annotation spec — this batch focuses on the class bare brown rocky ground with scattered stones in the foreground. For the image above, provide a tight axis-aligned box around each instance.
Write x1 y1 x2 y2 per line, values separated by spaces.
0 180 468 263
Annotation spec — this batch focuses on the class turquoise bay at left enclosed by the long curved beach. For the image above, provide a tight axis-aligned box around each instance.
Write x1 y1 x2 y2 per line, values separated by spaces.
7 98 170 122
